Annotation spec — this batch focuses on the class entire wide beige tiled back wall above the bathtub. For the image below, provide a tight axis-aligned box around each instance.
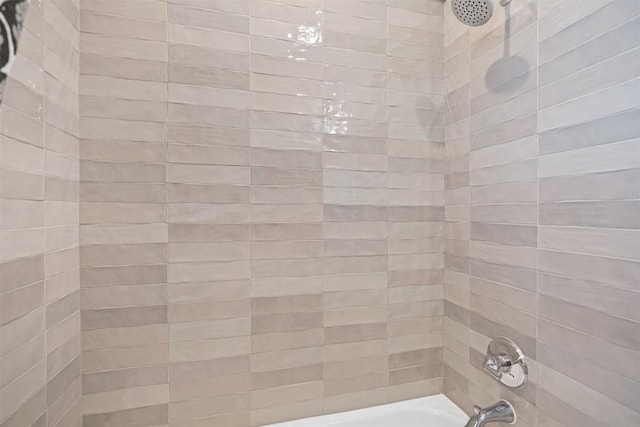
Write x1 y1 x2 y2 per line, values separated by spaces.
80 0 444 427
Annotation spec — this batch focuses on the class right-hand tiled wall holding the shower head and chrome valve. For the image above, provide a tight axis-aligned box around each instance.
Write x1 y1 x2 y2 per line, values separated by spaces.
444 0 640 427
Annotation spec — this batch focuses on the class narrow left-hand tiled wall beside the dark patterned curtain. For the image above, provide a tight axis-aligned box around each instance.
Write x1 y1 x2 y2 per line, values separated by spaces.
0 0 81 427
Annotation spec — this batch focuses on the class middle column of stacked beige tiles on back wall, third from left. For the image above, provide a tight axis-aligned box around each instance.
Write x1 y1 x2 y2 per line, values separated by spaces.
249 0 325 425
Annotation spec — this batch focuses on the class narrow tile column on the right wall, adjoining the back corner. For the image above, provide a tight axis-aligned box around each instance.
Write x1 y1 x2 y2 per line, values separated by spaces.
443 3 471 411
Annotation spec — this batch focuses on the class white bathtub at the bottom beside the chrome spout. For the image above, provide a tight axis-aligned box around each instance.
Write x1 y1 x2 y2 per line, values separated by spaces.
267 394 469 427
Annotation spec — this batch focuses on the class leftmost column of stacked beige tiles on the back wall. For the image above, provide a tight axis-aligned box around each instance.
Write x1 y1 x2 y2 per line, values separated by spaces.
80 0 170 426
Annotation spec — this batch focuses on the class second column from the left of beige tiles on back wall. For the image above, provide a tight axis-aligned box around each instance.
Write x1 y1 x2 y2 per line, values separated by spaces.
167 1 251 425
